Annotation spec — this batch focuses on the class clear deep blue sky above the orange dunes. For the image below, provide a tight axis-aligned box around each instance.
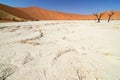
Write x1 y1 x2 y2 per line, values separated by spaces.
0 0 120 14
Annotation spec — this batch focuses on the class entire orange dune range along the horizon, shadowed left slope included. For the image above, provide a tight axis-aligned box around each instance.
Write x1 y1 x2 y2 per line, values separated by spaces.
0 4 120 21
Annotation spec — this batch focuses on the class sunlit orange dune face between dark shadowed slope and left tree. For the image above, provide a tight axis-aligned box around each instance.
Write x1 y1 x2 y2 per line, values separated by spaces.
17 7 93 20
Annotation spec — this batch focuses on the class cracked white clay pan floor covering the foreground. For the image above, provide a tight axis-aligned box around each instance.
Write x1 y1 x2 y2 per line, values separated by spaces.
0 21 120 80
